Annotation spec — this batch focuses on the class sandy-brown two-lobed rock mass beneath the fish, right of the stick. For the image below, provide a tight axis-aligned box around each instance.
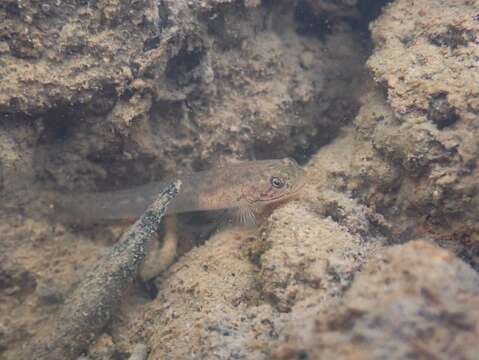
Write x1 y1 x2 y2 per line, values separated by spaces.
113 204 380 359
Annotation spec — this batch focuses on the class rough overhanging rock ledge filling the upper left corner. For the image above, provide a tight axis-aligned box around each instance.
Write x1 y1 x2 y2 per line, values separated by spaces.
0 0 154 112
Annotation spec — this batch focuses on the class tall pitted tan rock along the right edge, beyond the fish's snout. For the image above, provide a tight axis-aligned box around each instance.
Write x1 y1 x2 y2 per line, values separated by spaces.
350 0 479 266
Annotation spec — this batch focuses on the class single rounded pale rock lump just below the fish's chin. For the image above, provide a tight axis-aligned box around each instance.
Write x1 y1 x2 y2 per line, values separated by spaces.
260 205 380 316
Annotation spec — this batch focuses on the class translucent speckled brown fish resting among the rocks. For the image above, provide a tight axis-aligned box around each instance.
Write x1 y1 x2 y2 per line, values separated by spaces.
61 158 304 220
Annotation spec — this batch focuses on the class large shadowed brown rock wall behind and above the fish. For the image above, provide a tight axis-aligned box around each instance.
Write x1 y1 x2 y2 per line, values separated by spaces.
0 0 365 194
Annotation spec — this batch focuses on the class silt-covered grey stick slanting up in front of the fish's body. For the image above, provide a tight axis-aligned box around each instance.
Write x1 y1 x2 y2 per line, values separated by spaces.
28 181 181 360
